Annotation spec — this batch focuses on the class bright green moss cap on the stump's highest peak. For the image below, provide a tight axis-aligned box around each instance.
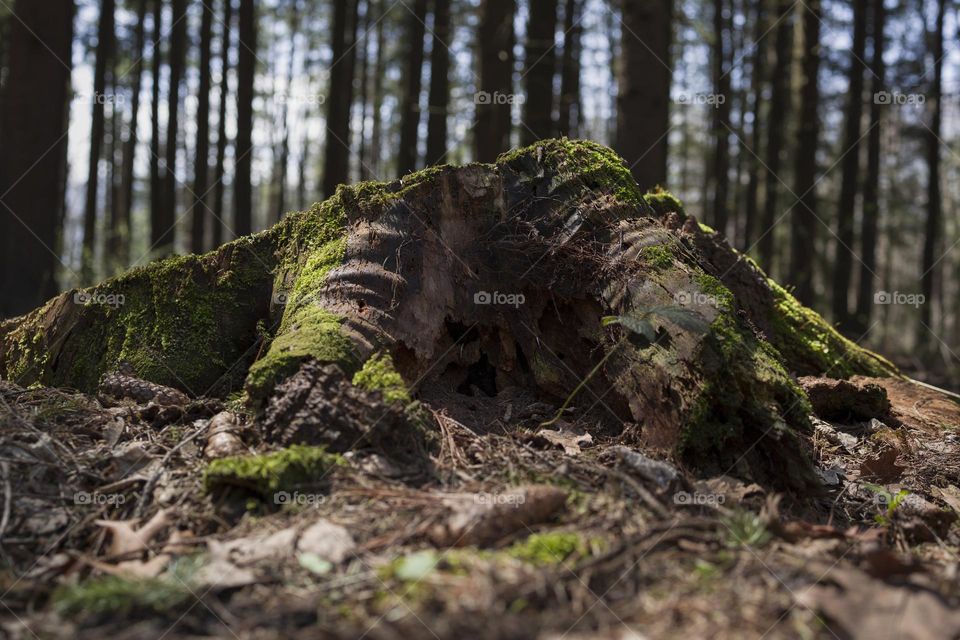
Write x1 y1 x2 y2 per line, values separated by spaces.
497 138 647 209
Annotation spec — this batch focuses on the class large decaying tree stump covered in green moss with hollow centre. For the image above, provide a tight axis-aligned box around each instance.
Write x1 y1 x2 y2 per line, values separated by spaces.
0 139 896 485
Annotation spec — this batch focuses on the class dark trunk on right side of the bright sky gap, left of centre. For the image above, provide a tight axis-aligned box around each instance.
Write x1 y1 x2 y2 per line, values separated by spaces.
323 0 358 198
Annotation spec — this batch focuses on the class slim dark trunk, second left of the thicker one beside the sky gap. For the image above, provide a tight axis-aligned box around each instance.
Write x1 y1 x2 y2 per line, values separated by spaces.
190 2 216 253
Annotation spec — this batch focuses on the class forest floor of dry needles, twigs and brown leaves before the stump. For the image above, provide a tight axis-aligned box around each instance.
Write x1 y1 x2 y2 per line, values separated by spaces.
0 378 960 640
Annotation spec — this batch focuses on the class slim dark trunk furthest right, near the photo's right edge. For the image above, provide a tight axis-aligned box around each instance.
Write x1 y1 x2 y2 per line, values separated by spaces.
917 0 946 353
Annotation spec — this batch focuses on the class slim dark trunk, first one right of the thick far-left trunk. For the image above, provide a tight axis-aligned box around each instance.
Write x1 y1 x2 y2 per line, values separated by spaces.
80 0 115 284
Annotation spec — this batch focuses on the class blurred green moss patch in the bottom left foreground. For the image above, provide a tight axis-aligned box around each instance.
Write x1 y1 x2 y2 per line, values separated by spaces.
51 558 199 617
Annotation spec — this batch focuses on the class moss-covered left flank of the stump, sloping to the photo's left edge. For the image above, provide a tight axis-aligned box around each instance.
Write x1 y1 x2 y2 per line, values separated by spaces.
0 228 276 395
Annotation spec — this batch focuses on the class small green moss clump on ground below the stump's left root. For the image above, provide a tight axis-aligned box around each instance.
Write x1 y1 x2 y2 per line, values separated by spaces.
203 445 343 496
